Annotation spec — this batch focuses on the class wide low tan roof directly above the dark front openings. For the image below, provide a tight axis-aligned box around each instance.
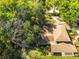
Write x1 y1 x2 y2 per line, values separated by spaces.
51 43 77 53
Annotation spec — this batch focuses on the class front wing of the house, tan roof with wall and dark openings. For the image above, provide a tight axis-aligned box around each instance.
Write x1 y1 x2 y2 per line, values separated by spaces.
51 43 77 56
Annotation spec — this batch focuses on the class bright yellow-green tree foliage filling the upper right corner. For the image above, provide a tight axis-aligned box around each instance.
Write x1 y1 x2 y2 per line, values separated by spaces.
46 0 79 25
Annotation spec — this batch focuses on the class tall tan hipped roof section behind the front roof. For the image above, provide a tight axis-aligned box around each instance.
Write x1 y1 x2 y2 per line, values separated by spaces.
53 25 71 41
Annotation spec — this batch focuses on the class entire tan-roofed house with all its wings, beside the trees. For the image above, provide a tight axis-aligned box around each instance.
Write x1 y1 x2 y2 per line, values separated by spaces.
40 18 77 56
